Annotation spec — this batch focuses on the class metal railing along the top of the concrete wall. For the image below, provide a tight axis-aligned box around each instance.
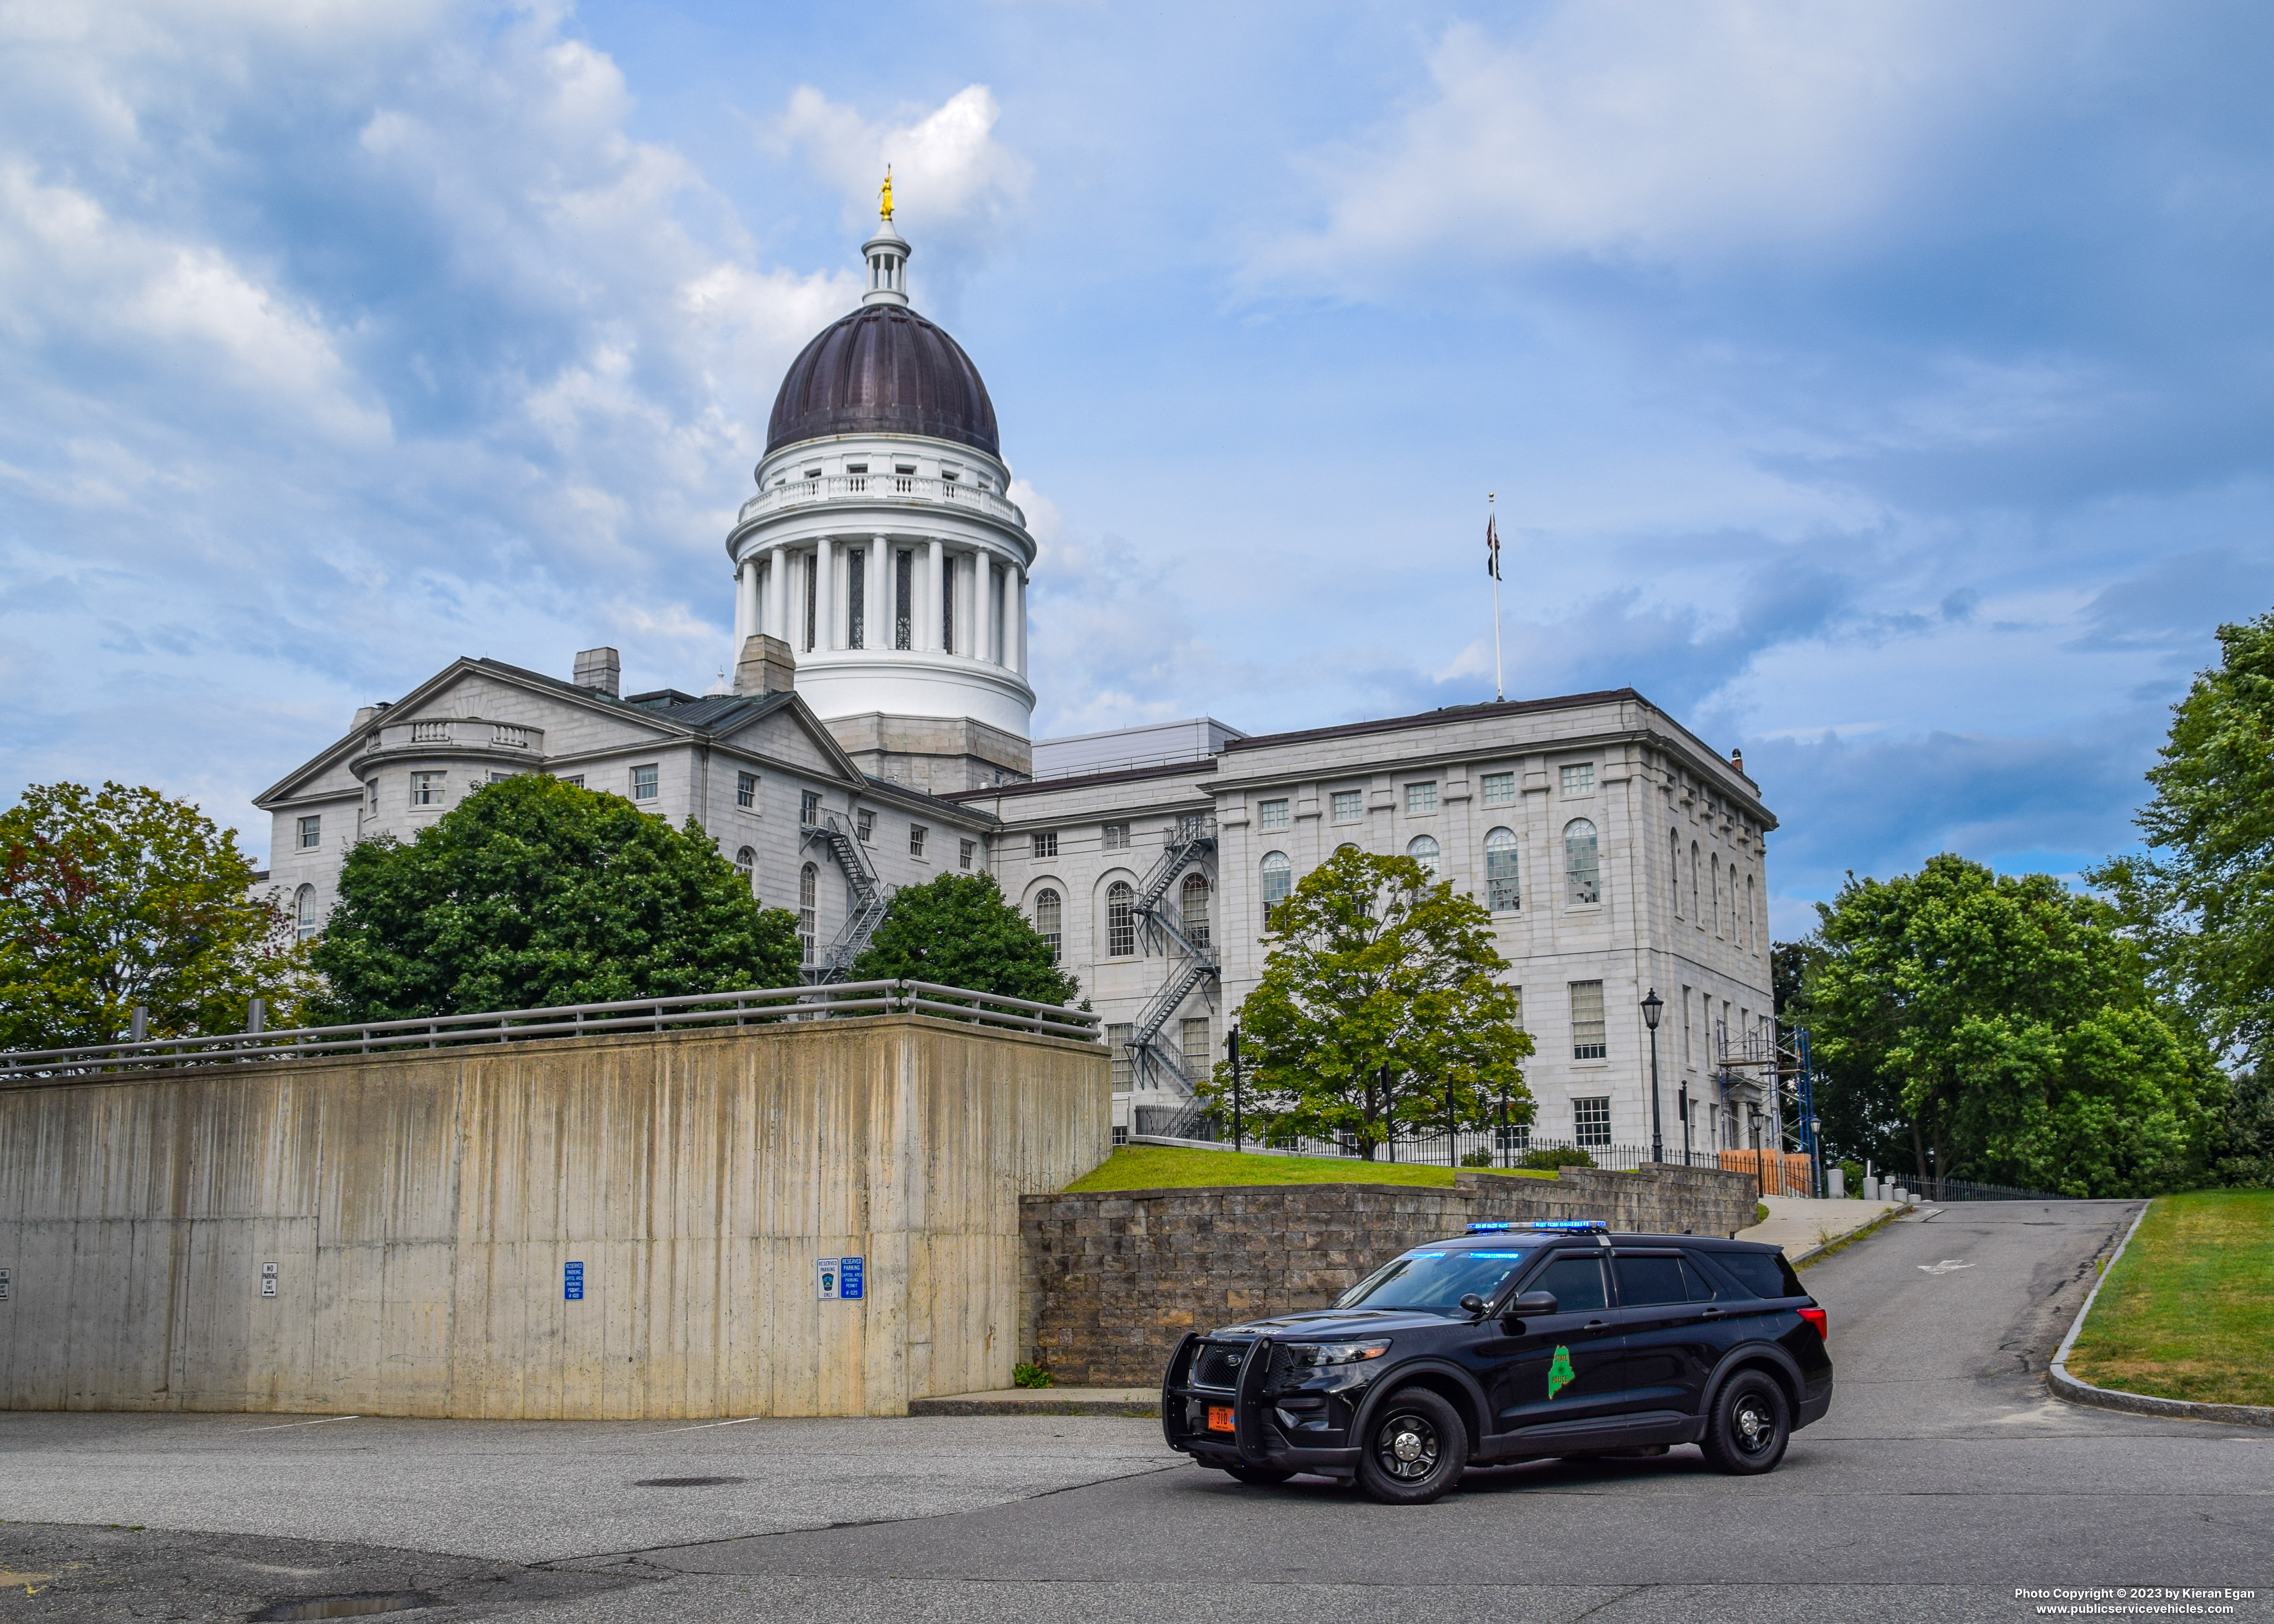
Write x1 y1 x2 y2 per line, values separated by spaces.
0 980 1101 1085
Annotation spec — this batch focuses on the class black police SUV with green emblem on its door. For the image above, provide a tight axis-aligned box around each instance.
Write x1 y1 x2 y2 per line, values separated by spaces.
1160 1221 1833 1503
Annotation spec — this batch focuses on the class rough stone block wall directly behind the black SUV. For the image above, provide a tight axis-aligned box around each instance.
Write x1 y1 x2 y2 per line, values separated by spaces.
1019 1167 1755 1387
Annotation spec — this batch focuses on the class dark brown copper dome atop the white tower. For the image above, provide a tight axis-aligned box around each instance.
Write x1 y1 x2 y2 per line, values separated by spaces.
766 302 1000 457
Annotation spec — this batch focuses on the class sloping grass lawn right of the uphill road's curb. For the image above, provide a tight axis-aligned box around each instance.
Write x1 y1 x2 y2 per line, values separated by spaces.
2069 1189 2274 1403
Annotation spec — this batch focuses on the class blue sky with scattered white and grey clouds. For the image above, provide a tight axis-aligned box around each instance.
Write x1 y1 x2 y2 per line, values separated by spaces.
0 0 2274 935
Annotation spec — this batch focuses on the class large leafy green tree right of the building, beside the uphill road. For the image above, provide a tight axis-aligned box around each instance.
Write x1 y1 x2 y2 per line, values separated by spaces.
1808 853 2224 1196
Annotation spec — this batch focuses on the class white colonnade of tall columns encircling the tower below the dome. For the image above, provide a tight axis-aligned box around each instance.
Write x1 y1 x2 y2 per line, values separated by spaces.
735 535 1025 676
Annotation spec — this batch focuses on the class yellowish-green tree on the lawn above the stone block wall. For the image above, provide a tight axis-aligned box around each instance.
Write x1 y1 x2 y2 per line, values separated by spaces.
1203 848 1533 1162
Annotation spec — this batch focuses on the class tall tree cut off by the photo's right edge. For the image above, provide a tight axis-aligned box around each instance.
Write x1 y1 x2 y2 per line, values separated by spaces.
2090 614 2274 1067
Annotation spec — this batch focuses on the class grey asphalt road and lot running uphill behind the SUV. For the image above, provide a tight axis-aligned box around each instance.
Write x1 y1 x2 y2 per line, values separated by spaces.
0 1203 2274 1624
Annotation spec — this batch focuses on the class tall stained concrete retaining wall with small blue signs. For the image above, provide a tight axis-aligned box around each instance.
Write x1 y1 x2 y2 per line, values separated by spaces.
0 1017 1112 1419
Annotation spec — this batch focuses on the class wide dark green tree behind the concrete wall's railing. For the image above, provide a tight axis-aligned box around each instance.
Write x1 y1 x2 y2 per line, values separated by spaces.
312 774 798 1021
